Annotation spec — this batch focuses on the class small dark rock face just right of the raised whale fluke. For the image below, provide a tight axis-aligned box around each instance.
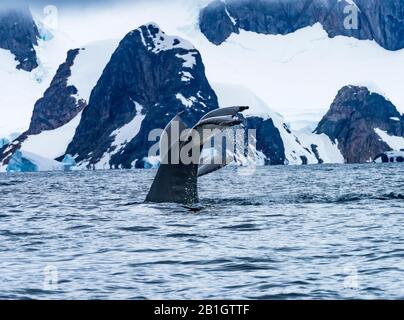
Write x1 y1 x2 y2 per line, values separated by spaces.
246 117 286 165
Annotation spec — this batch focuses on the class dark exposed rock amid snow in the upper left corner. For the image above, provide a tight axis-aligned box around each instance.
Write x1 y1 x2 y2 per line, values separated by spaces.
0 6 39 71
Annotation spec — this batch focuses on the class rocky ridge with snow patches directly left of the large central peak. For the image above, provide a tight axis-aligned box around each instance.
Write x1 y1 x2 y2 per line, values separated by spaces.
0 40 118 170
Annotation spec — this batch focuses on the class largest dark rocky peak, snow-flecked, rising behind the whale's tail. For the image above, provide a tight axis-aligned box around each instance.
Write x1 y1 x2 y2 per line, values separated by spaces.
67 24 218 168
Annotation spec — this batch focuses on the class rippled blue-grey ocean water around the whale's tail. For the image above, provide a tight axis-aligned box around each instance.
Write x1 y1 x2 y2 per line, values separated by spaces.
0 164 404 299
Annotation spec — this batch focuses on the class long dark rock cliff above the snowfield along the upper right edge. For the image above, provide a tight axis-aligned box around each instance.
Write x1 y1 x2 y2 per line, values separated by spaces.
199 0 404 50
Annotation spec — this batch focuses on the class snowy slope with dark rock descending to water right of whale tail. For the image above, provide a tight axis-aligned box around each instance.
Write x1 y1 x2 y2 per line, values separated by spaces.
213 83 344 164
